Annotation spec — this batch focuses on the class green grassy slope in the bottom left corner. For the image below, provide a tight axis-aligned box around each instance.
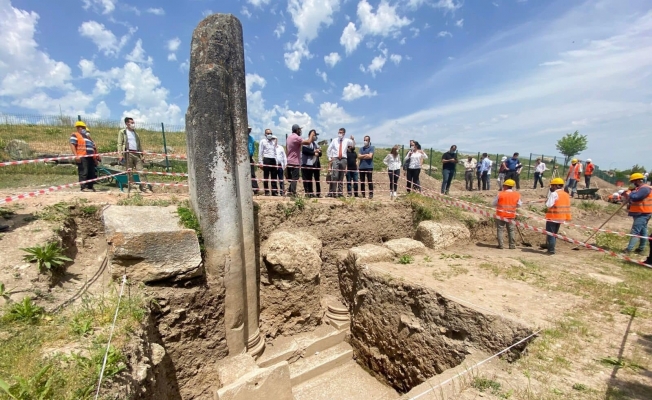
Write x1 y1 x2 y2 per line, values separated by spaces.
0 288 146 399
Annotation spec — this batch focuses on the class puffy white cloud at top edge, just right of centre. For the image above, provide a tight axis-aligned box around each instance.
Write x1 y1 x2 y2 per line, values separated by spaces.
340 0 412 54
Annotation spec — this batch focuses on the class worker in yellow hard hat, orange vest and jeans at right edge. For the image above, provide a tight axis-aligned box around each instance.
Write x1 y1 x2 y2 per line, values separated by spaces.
623 172 652 254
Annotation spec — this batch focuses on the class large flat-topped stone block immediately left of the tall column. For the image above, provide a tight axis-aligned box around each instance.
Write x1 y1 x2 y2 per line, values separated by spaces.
102 206 203 282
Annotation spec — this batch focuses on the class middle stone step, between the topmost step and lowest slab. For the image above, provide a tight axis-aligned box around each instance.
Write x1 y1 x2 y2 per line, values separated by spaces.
290 342 353 386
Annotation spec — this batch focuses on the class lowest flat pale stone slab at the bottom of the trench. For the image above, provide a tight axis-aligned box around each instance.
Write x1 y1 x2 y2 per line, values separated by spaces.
292 360 399 400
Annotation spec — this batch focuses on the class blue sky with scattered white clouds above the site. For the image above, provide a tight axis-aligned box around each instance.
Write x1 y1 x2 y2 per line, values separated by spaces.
0 0 652 168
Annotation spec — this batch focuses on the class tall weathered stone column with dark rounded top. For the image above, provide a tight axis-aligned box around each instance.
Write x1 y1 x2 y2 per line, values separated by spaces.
186 14 264 356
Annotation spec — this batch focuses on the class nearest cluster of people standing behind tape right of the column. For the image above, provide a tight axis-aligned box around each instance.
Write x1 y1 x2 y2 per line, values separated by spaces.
248 124 428 199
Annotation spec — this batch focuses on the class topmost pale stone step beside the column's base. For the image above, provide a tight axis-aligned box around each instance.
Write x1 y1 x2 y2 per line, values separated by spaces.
256 324 347 367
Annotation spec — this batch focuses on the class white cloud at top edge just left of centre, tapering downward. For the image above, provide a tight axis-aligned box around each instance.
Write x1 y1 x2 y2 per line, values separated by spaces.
283 0 340 71
